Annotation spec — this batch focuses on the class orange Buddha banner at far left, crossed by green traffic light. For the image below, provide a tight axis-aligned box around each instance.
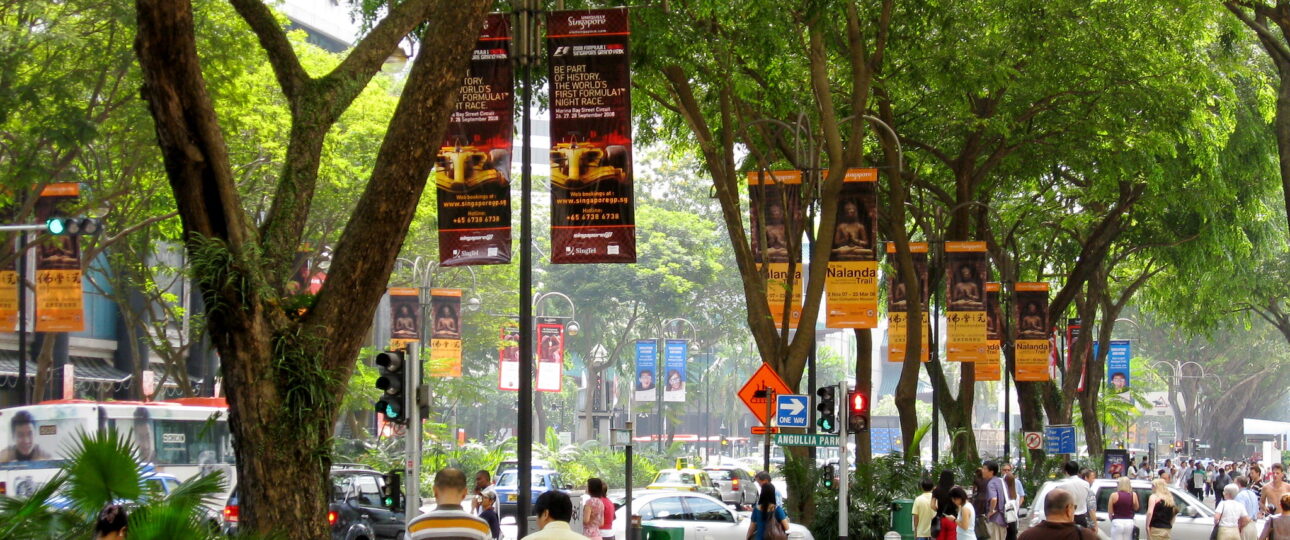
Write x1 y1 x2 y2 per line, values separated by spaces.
34 183 85 333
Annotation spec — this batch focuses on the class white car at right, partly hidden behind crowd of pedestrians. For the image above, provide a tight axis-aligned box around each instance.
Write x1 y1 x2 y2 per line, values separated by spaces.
1022 478 1263 540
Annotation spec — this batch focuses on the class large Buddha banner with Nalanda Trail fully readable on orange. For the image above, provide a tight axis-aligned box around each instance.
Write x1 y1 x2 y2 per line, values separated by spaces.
824 169 878 329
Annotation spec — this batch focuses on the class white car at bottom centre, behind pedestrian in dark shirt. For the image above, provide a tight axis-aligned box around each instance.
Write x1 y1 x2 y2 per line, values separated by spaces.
614 491 814 540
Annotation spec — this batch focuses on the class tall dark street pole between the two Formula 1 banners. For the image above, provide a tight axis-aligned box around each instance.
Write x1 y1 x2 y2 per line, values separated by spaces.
515 0 537 537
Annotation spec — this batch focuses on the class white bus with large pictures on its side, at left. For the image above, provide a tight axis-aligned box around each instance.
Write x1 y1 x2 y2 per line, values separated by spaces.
0 398 236 496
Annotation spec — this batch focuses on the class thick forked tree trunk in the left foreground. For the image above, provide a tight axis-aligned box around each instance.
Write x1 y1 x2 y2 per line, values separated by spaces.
134 0 489 539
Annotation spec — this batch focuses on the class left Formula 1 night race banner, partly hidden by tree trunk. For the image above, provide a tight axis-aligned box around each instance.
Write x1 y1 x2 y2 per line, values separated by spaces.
433 13 515 267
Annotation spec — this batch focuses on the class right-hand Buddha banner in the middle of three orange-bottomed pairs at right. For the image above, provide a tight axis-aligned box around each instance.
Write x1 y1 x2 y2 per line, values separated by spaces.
946 242 989 362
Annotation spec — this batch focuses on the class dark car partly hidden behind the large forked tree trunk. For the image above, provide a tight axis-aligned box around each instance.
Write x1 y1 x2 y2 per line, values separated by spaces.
224 468 406 540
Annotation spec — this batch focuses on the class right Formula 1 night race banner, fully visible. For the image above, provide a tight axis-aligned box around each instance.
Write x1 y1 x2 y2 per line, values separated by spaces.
547 8 636 264
